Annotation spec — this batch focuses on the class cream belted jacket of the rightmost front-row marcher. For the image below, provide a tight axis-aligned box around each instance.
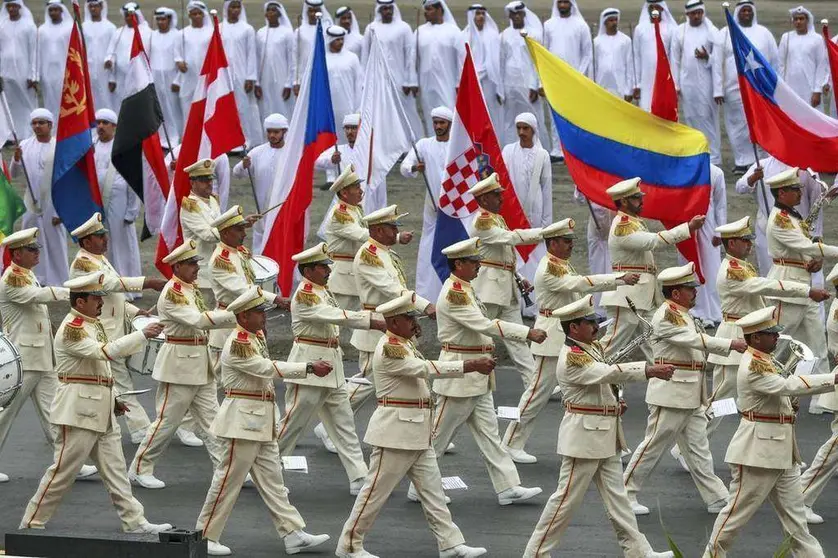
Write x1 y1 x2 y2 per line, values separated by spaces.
725 348 835 470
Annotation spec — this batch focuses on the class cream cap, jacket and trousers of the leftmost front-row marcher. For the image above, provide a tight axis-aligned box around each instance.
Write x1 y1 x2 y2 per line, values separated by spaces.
20 273 162 532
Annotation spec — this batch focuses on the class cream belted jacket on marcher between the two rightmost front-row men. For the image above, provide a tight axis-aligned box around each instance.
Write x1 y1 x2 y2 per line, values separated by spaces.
646 300 730 409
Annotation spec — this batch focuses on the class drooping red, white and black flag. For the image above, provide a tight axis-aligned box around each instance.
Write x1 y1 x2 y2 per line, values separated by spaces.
111 15 169 239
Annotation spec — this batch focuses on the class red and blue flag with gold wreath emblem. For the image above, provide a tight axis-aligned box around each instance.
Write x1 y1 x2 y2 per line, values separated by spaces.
52 15 103 231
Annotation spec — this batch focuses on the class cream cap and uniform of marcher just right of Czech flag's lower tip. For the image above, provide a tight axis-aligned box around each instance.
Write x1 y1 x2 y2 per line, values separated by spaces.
278 242 371 491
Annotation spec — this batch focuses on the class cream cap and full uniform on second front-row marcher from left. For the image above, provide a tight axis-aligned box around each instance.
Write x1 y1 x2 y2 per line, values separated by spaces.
195 287 329 556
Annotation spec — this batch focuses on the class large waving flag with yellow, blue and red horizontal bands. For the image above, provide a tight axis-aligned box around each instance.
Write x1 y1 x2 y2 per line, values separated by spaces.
527 38 710 280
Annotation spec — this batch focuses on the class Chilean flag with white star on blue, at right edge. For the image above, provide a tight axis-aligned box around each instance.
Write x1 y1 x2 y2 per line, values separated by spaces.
725 10 838 172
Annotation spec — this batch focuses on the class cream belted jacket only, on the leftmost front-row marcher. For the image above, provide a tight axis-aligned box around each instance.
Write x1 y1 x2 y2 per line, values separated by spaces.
50 310 145 432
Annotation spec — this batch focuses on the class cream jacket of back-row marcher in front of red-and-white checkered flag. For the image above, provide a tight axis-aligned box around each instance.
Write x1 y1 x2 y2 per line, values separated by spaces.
470 209 541 306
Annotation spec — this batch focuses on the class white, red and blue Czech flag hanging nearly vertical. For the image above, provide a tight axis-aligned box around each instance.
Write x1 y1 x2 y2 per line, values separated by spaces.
254 20 337 296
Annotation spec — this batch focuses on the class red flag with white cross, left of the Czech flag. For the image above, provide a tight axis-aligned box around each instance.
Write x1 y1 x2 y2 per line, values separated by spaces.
155 15 245 277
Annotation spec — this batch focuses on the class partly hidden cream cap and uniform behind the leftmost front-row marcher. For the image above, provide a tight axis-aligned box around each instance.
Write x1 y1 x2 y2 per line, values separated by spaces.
70 212 151 438
